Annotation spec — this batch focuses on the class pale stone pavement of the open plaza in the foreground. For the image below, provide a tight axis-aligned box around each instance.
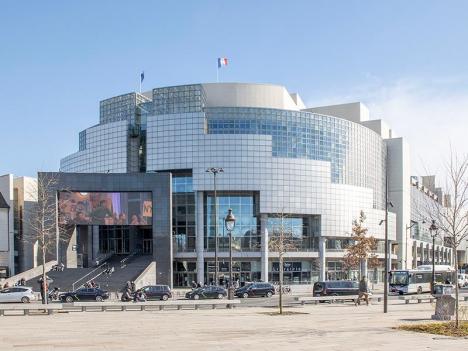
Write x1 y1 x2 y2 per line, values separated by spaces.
0 303 468 351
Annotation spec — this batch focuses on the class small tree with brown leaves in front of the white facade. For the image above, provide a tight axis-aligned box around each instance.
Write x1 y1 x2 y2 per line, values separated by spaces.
343 211 379 278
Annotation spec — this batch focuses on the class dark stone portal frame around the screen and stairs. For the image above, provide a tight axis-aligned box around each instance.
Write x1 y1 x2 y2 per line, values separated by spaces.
38 172 173 287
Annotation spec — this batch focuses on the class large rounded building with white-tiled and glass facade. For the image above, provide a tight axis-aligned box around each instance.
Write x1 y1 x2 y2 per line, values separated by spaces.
54 83 450 286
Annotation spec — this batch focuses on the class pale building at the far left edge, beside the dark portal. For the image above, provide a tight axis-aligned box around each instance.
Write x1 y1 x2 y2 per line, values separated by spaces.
0 174 37 276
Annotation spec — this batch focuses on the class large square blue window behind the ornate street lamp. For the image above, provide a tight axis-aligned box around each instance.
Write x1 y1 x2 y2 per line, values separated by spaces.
205 194 260 251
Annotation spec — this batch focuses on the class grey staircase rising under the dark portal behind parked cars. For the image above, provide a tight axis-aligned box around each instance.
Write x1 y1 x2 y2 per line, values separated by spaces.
27 255 153 292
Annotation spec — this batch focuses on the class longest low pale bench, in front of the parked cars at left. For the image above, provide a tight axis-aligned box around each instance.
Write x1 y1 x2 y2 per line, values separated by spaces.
63 300 240 312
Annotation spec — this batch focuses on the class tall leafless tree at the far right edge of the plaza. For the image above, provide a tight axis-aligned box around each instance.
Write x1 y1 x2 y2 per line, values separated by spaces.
423 150 468 328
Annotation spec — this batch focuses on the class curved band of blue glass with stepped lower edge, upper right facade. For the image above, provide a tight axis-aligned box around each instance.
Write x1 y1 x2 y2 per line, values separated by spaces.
205 107 386 209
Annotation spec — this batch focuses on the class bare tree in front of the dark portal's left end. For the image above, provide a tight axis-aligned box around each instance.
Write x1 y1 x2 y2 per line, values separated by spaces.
22 175 65 303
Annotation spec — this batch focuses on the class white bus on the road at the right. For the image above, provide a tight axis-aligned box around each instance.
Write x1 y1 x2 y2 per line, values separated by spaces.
389 265 457 295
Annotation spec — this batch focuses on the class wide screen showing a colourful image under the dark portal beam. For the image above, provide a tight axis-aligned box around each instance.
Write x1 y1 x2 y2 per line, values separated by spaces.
59 191 153 225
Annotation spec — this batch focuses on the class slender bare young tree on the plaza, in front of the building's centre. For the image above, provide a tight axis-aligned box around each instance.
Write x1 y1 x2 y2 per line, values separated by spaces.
268 212 297 314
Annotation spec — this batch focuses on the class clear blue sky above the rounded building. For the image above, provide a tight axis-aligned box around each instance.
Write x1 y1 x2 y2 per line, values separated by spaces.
0 0 468 175
